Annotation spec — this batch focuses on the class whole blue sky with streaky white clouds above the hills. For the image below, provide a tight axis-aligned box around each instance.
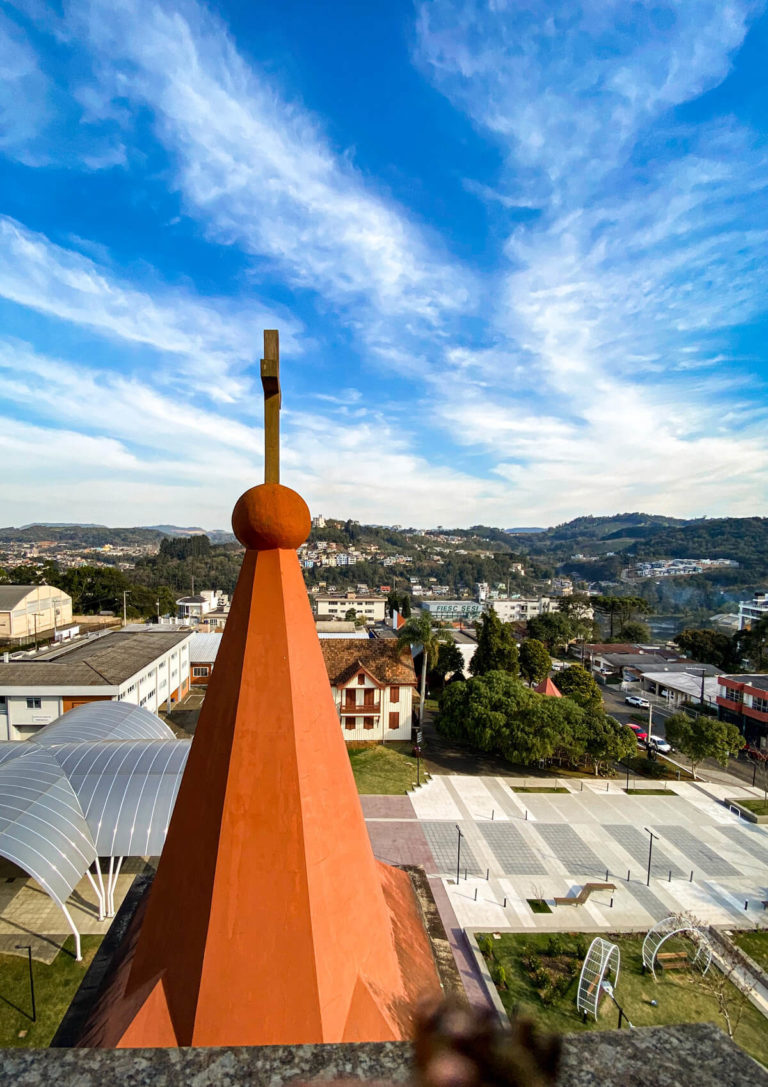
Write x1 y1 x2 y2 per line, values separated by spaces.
0 0 768 528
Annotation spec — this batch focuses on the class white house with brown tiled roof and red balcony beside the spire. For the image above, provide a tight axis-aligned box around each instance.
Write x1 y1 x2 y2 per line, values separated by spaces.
320 638 416 742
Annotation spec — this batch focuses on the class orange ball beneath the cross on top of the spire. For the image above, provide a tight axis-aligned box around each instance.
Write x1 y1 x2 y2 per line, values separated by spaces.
232 483 312 551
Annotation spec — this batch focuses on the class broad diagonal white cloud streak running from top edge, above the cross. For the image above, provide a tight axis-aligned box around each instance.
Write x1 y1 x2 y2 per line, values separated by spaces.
72 0 470 334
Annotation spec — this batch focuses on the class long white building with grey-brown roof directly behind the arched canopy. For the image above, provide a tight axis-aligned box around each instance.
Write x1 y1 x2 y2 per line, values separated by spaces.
0 630 192 740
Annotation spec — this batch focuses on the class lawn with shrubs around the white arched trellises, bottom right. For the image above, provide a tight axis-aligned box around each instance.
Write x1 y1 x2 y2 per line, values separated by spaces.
481 933 768 1064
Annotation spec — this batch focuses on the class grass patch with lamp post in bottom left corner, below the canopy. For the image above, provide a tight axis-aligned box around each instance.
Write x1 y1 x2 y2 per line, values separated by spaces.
0 936 102 1049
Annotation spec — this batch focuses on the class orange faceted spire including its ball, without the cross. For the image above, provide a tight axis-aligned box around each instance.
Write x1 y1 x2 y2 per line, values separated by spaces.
89 330 440 1047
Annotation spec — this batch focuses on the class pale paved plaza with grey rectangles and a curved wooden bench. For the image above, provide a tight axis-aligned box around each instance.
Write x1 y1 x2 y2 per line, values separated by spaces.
363 776 768 932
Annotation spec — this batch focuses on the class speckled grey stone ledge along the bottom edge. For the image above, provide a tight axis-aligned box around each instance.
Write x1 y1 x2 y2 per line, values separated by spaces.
0 1023 768 1087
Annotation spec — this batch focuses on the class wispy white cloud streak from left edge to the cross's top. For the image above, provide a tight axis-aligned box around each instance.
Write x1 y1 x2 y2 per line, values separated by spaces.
0 216 297 400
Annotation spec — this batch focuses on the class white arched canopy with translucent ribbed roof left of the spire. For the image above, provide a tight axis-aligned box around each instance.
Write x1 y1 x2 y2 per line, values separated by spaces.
0 701 190 959
